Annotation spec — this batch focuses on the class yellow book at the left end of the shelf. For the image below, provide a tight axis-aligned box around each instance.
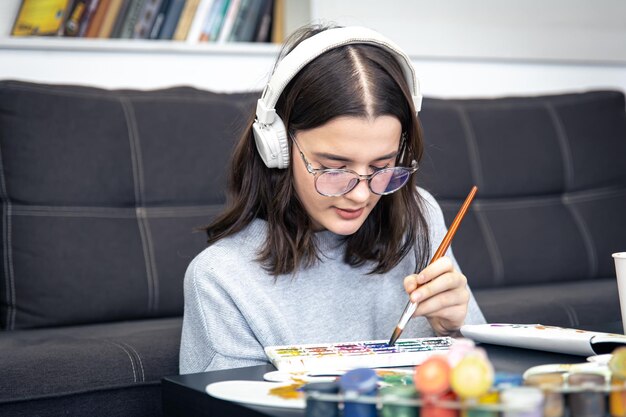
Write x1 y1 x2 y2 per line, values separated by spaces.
11 0 71 36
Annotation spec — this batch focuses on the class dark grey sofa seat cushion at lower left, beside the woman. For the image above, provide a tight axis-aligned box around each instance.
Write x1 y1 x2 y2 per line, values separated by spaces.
0 318 182 404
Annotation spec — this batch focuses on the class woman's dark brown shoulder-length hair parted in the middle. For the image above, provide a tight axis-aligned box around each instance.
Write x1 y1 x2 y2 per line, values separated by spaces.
205 25 430 276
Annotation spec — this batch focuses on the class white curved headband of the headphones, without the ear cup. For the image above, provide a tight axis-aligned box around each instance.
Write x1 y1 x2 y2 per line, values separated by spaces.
256 26 422 124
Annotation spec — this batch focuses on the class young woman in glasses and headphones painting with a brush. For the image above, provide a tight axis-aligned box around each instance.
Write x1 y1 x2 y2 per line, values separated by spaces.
180 26 484 373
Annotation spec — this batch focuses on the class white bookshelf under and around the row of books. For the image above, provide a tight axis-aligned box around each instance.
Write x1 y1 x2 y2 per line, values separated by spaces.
0 0 311 91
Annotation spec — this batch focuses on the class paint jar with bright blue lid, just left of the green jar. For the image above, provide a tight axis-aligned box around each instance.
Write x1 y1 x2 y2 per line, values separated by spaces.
339 368 378 417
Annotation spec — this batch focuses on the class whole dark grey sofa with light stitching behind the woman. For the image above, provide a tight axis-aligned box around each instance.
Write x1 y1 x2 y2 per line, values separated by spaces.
0 81 626 416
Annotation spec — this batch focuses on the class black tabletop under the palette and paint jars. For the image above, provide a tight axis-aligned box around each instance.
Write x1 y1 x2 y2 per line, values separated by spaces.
162 342 596 417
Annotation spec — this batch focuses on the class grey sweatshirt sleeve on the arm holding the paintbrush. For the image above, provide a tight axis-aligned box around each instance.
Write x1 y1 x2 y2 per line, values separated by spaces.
418 188 486 324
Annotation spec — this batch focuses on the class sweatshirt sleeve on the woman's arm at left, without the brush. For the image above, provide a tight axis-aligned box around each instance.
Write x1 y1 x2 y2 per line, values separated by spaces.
179 254 267 374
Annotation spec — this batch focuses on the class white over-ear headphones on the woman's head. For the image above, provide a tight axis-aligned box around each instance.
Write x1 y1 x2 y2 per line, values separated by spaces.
252 26 422 169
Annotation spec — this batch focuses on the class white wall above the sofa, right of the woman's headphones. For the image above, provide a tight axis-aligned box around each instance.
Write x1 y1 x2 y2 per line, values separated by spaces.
311 0 626 97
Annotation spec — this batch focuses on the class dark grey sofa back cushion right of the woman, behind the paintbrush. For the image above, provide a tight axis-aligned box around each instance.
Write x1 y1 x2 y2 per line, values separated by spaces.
419 91 626 297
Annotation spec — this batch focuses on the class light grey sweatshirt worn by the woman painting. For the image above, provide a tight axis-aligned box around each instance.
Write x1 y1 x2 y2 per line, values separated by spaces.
180 189 485 374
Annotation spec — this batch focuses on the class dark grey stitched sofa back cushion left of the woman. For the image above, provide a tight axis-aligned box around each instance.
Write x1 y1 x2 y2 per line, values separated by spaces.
0 81 256 330
